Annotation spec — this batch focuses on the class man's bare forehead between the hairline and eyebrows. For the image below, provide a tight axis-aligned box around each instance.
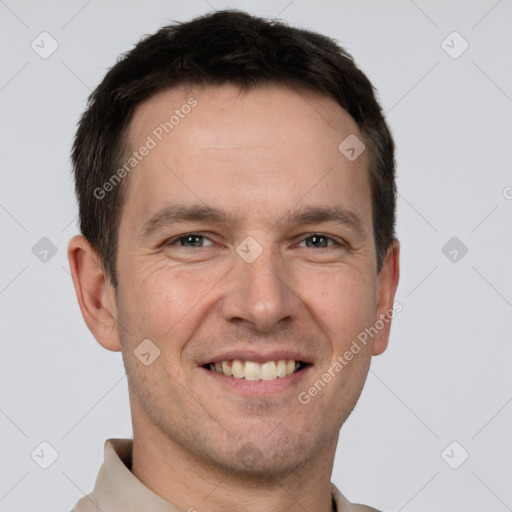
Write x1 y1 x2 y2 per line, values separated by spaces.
120 85 371 236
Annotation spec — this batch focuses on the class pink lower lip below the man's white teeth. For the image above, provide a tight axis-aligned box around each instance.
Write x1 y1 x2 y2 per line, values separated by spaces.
200 365 311 397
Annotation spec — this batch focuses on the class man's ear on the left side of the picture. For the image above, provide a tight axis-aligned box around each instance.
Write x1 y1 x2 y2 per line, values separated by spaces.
68 235 121 351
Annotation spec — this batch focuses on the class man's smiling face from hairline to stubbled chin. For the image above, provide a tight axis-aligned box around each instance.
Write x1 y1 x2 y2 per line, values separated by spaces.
81 86 396 475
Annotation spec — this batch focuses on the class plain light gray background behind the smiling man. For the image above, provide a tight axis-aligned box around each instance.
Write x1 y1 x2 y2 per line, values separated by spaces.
0 0 512 512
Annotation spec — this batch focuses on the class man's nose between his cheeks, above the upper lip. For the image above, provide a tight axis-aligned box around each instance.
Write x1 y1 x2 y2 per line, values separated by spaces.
221 243 300 332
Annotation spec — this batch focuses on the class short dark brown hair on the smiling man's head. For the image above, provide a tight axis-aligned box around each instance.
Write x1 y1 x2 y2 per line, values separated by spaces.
72 10 396 289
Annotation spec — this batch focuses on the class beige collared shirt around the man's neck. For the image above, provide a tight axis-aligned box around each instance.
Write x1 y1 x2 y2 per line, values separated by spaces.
72 439 378 512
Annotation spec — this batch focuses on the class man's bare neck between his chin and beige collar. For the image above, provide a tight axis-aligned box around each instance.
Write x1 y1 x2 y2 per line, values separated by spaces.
131 410 337 512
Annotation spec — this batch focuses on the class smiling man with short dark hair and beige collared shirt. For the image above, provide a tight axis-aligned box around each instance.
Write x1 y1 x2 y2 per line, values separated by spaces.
68 11 399 512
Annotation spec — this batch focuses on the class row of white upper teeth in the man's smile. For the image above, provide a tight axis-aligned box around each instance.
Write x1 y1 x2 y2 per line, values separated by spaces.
210 359 300 380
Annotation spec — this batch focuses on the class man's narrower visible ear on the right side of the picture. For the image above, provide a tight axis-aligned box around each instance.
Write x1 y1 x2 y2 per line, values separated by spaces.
372 238 400 356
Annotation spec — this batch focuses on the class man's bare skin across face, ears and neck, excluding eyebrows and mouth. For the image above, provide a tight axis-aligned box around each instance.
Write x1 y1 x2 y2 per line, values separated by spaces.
68 85 399 512
